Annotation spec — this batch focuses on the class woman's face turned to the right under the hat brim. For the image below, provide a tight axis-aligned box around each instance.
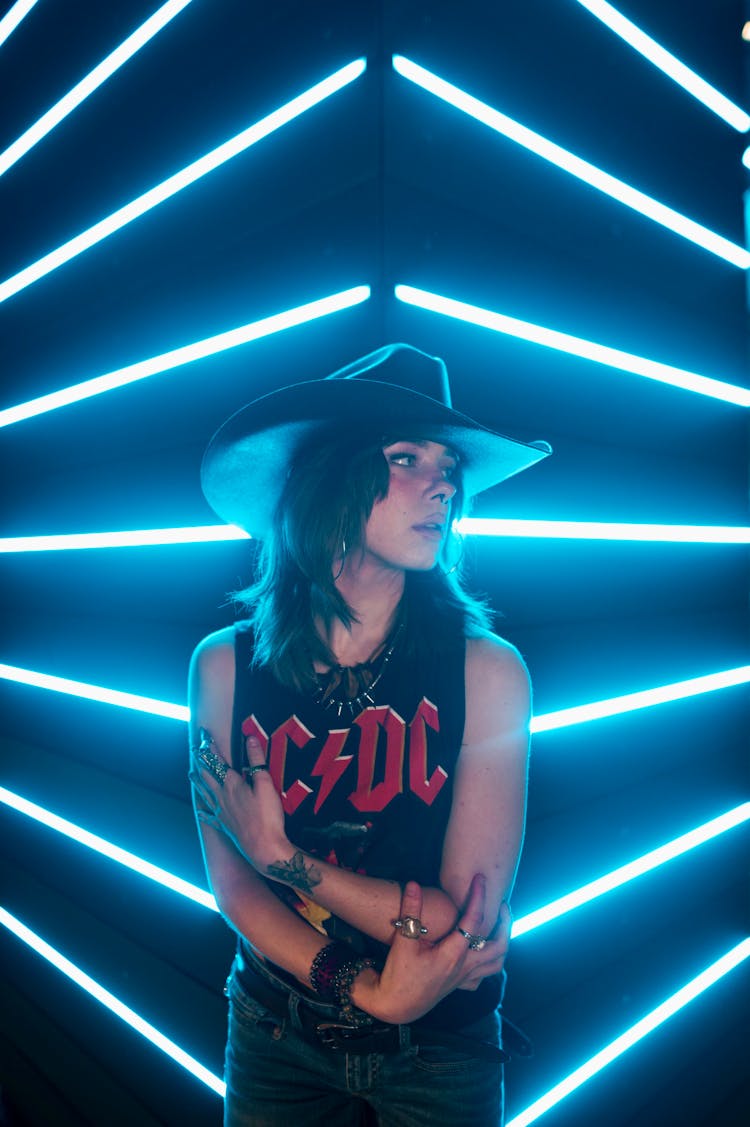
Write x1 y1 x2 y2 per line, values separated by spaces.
362 441 458 571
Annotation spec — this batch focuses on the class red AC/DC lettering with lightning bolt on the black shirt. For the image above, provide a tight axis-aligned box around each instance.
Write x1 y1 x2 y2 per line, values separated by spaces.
242 696 448 815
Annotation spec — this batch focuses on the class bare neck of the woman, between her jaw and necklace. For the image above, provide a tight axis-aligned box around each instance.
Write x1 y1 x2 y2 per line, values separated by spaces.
326 560 404 665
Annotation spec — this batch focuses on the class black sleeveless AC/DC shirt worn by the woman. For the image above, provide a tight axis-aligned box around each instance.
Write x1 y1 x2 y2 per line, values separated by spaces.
232 622 502 1028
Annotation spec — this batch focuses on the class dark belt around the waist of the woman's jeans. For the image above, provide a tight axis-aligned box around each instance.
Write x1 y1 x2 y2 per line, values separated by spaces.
239 960 509 1064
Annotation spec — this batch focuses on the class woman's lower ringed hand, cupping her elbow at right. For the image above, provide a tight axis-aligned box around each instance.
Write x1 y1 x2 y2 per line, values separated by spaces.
352 875 510 1024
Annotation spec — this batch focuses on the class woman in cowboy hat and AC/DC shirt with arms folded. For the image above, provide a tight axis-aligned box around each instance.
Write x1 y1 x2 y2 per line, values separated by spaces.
189 345 549 1127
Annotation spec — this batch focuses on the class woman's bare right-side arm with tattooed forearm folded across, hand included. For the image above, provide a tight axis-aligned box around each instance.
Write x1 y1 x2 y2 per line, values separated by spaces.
196 636 530 960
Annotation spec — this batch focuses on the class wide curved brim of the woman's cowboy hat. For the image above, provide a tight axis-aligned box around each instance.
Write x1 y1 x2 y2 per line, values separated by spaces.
201 380 552 539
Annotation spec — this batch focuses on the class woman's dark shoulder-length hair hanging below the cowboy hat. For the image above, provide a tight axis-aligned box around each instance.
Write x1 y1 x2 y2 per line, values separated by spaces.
232 427 491 690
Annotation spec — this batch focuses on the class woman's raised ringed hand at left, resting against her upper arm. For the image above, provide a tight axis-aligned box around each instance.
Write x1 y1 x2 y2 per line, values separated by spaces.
189 729 287 873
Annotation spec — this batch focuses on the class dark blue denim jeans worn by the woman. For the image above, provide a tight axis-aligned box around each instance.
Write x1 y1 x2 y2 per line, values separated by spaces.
224 973 503 1127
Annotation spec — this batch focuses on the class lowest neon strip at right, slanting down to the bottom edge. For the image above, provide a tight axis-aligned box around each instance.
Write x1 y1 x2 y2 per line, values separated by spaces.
506 939 750 1127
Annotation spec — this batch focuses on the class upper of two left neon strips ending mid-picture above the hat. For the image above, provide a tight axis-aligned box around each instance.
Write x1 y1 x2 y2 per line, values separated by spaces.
0 59 367 302
